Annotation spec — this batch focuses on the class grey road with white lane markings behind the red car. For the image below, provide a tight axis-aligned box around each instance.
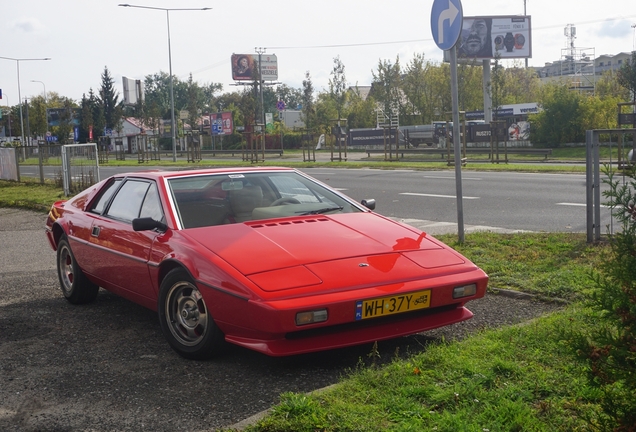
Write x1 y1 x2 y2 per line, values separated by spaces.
21 161 611 232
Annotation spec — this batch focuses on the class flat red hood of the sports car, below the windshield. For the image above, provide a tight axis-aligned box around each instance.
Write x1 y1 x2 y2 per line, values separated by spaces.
186 213 475 291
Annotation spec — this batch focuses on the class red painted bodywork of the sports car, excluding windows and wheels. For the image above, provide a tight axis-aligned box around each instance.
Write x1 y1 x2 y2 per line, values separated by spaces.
47 168 488 355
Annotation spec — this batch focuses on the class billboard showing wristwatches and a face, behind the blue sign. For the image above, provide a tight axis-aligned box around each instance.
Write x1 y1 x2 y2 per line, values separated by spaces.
457 15 532 59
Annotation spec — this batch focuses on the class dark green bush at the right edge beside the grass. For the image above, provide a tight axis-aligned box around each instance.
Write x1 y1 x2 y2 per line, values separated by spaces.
577 165 636 431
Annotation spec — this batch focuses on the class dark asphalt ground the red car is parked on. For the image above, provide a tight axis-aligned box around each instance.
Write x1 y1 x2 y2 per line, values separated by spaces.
0 208 558 432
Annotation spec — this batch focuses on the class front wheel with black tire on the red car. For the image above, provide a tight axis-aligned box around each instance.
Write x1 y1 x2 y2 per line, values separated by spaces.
157 269 225 360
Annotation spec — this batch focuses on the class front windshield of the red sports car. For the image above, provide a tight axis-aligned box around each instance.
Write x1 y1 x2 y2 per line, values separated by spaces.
168 171 361 228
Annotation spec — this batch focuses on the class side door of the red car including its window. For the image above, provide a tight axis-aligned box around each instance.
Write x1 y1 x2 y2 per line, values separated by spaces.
89 178 165 304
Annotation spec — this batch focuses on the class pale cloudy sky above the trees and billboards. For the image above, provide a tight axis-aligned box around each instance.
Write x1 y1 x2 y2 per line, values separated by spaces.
0 0 636 106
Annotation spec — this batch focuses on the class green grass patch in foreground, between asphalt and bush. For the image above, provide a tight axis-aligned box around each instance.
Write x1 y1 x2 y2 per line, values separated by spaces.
247 307 600 432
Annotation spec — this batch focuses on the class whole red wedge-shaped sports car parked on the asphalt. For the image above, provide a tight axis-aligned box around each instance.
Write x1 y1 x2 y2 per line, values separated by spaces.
46 167 488 359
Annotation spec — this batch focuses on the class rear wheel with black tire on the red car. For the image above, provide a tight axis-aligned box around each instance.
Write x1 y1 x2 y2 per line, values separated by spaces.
57 235 99 304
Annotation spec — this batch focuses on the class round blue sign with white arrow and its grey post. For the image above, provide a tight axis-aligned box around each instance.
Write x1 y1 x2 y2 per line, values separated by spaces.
431 0 464 243
